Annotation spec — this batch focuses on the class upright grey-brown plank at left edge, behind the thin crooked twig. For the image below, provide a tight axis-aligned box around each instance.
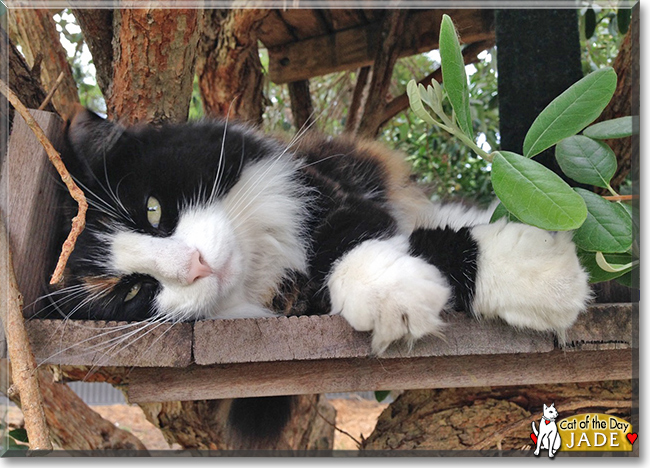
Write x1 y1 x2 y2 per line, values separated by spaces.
0 110 63 316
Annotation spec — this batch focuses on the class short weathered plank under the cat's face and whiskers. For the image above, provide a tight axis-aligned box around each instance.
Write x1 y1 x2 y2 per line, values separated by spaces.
26 320 192 367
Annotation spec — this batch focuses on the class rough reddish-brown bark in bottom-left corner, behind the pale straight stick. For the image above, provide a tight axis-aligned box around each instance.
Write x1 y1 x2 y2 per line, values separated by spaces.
0 361 146 450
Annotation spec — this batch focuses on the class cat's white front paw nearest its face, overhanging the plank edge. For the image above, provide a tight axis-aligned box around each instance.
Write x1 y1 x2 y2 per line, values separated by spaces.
327 236 451 354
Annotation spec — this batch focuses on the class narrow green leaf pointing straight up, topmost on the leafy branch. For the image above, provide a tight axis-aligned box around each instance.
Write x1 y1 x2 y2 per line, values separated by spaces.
439 15 474 138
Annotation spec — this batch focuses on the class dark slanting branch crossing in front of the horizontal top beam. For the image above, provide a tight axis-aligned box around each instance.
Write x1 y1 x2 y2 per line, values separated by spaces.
357 10 407 138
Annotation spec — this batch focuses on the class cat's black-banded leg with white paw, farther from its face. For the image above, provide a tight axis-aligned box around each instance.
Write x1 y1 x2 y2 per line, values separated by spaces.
410 216 591 338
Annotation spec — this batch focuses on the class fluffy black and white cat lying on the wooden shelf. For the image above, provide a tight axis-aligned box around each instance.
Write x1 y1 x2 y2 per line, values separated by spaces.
49 107 590 446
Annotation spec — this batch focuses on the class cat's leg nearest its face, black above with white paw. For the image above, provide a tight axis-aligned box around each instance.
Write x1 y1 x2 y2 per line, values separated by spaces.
311 204 451 354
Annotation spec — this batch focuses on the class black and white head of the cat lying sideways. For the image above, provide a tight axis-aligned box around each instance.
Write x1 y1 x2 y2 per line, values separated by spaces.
49 110 294 321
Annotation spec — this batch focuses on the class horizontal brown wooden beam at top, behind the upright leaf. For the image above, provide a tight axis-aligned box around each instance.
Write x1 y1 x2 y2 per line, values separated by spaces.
268 10 494 83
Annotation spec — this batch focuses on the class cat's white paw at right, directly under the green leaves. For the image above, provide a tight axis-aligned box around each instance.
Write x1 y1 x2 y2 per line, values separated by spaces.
472 220 591 336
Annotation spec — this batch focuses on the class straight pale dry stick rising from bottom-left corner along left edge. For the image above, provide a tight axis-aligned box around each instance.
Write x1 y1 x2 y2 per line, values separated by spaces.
0 219 52 450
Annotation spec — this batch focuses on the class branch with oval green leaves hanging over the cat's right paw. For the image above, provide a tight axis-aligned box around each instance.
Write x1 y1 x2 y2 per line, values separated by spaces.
407 15 639 282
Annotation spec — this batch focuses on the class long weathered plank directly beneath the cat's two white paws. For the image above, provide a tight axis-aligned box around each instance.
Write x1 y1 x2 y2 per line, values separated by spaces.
194 312 554 365
